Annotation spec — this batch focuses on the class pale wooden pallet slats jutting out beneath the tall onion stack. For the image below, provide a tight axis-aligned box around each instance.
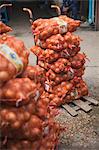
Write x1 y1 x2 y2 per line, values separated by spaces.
62 96 99 117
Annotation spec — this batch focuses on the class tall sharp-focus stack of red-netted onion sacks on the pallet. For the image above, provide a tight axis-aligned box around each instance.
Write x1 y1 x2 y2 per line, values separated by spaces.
31 16 88 106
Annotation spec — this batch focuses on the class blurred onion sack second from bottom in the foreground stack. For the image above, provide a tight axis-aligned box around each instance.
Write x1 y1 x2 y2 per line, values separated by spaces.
0 108 42 141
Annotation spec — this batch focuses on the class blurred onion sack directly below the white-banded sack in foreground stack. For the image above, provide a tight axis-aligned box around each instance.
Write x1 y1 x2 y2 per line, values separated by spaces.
0 78 40 106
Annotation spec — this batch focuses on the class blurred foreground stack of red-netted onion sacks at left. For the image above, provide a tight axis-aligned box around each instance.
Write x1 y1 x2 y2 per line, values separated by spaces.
0 30 60 150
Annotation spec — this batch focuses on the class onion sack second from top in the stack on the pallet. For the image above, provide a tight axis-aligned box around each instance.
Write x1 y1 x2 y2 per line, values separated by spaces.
35 32 81 52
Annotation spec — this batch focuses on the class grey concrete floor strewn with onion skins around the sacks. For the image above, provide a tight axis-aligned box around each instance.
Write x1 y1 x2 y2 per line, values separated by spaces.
9 2 99 150
